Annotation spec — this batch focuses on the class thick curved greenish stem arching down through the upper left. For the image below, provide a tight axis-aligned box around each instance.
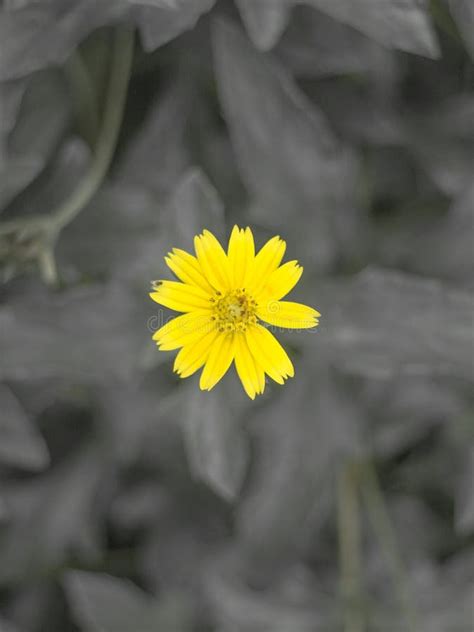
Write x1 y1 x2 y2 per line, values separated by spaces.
52 29 134 234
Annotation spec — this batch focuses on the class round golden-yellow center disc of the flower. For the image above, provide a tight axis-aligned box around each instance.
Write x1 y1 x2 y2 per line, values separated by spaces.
211 288 257 332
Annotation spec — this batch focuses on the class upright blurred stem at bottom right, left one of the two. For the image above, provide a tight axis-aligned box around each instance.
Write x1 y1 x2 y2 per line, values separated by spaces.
337 463 365 632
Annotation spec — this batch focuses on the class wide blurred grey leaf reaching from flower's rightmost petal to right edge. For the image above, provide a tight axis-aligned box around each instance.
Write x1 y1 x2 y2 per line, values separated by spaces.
316 269 474 380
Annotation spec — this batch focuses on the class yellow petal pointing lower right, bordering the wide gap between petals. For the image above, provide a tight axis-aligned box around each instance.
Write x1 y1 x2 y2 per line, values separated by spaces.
247 325 295 384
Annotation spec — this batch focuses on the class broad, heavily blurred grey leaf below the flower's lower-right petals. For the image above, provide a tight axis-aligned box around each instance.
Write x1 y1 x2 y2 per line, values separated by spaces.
238 358 361 581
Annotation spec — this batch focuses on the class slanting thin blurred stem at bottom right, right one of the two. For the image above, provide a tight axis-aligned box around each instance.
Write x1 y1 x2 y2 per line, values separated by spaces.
362 461 418 632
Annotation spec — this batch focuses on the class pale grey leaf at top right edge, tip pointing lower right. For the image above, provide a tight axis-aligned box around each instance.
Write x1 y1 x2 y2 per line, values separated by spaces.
306 0 440 58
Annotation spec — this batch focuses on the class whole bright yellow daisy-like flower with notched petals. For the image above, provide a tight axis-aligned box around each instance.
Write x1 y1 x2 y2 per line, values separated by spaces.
150 226 320 399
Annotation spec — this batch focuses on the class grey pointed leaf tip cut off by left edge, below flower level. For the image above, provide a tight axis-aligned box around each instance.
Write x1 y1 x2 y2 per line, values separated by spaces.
0 384 49 470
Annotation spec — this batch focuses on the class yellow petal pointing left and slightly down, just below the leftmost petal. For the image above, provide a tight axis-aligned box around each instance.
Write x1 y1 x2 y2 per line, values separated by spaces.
153 311 215 351
